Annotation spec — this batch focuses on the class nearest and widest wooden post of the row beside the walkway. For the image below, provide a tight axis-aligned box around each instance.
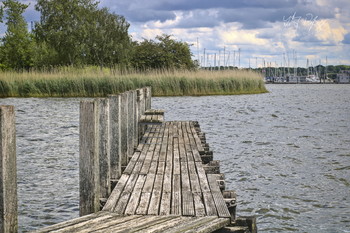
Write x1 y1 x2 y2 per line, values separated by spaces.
79 100 100 216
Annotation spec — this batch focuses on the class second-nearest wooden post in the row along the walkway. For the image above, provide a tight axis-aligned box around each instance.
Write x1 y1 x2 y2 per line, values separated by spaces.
97 98 111 202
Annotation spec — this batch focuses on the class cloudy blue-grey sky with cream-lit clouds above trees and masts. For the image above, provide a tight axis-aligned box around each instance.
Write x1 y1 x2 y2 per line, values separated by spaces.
0 0 350 68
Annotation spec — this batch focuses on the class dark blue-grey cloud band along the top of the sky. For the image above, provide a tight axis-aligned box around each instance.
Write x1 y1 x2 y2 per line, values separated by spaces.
101 0 342 29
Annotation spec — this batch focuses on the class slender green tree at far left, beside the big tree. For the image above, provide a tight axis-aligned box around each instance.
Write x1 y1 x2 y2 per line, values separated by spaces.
0 0 33 69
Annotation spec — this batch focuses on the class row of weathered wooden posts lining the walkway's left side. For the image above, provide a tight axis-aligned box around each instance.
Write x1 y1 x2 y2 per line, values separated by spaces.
79 87 151 211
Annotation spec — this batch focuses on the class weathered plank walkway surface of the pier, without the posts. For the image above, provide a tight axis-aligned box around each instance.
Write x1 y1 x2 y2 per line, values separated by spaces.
34 121 231 232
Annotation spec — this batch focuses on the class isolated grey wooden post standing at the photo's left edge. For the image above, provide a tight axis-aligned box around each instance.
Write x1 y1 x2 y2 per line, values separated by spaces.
0 105 18 233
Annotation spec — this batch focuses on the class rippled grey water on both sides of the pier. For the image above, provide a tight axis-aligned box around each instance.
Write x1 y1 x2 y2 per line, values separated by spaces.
0 85 350 232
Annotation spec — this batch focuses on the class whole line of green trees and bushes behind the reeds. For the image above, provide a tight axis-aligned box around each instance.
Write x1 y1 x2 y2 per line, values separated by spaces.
0 0 196 70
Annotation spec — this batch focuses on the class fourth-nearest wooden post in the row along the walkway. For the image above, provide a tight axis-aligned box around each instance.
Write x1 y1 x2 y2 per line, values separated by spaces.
120 92 129 170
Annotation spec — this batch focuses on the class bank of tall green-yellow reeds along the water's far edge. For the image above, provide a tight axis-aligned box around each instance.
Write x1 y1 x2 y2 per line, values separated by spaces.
0 67 266 97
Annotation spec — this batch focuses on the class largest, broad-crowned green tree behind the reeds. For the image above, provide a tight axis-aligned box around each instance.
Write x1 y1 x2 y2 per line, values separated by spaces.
35 0 131 67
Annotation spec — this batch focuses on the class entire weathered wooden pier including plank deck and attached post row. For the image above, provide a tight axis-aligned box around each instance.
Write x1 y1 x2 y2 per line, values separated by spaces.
0 88 256 232
